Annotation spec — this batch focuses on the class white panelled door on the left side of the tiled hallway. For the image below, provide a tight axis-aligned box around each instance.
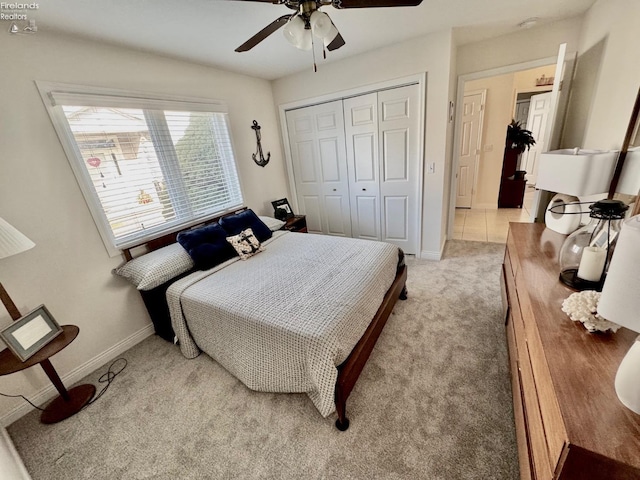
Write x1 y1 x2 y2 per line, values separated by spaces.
456 90 486 208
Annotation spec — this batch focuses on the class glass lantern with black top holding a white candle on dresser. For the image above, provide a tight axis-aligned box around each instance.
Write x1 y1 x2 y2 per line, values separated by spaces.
560 199 629 292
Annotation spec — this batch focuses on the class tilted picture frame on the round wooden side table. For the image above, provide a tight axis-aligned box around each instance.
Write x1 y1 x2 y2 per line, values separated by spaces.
0 305 62 362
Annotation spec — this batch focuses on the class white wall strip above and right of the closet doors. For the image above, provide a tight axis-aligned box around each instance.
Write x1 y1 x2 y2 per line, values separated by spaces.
273 31 453 258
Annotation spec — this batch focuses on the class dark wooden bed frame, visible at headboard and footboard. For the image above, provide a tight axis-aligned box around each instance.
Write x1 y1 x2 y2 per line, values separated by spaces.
122 207 407 431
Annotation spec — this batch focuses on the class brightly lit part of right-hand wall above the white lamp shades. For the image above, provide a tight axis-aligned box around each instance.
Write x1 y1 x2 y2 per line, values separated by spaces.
578 0 640 149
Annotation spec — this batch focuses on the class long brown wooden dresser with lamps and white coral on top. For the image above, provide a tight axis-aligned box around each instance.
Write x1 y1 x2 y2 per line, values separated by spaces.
502 223 640 480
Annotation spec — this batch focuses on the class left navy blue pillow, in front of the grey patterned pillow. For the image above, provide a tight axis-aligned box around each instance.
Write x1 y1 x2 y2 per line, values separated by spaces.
178 223 238 270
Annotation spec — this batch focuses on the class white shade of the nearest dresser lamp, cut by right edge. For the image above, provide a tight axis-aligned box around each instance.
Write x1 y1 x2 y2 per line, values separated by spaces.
598 215 640 334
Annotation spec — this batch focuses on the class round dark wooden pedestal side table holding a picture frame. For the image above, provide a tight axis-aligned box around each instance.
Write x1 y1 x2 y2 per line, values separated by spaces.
0 325 96 423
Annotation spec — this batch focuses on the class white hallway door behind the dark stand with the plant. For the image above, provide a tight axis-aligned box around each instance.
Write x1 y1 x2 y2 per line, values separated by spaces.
520 92 551 185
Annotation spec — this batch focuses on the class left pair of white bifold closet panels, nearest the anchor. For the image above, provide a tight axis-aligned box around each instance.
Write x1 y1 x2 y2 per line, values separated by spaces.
286 100 351 236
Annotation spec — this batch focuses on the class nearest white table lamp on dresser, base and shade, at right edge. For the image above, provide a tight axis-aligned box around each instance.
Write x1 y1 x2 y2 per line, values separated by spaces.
598 215 640 414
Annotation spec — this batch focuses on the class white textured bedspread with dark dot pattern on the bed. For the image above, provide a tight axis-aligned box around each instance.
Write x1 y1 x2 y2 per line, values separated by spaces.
167 232 398 417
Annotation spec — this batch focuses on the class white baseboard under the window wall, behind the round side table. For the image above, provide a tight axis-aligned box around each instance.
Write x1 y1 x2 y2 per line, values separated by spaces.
0 324 154 427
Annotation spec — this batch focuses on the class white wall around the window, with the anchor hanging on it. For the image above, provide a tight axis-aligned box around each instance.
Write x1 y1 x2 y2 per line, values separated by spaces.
0 29 288 423
